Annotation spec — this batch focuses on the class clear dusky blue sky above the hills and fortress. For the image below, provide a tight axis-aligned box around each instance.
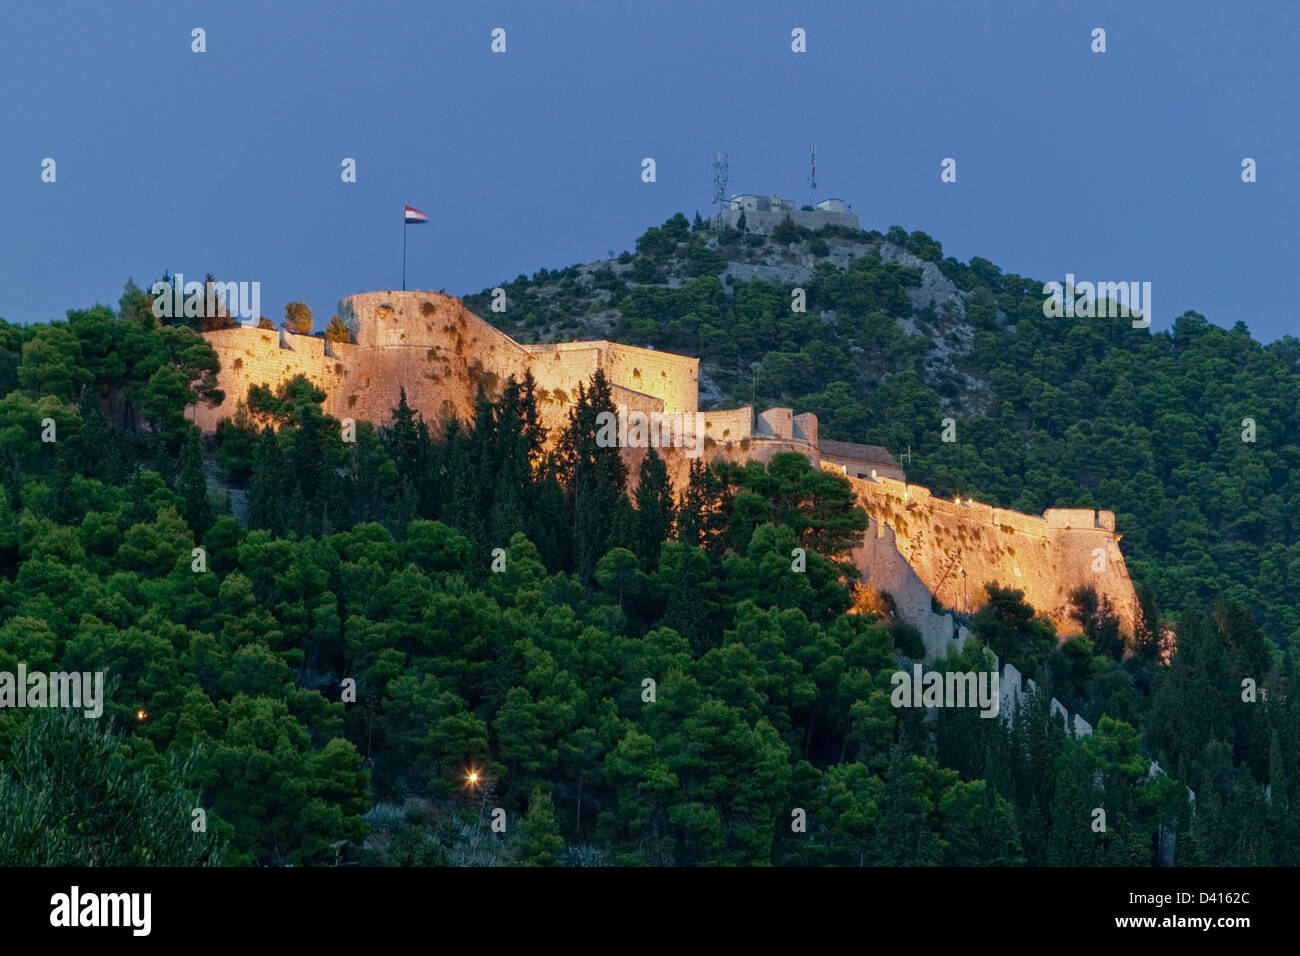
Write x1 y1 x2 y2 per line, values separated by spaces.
0 0 1300 341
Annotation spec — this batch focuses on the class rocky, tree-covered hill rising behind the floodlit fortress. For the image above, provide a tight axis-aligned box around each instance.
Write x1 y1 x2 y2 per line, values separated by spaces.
465 213 1300 646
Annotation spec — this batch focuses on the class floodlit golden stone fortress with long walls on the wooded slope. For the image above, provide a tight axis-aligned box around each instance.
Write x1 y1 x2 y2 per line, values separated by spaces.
195 290 1138 656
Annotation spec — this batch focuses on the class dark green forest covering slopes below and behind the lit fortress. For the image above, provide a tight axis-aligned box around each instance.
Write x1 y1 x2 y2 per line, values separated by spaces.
0 220 1300 865
